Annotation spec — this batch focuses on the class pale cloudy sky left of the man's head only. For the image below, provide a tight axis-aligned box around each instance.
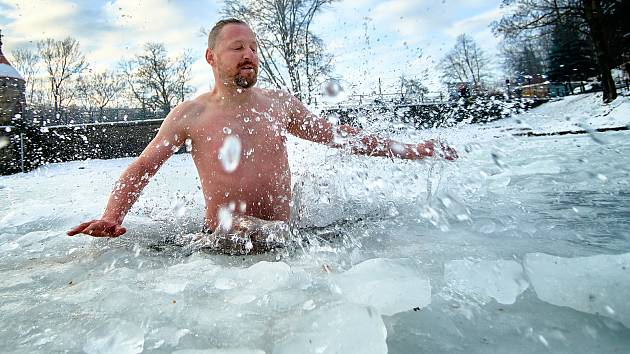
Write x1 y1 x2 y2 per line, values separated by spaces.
0 0 220 95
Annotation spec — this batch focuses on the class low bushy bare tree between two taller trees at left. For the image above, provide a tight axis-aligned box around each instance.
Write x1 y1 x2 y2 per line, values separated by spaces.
77 71 123 117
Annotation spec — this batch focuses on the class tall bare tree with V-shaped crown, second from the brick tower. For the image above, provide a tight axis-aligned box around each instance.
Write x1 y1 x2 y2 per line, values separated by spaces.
37 37 87 112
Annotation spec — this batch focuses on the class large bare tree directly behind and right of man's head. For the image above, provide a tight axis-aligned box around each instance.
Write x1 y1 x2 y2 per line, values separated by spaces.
224 0 335 103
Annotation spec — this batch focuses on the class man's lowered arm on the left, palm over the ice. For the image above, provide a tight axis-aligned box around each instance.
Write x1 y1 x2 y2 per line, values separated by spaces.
68 104 187 237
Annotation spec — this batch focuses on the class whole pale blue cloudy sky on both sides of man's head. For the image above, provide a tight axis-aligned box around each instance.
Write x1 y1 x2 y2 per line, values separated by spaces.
0 0 503 98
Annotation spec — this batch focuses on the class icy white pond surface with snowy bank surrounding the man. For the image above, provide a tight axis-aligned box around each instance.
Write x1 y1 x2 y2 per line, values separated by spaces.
0 92 630 353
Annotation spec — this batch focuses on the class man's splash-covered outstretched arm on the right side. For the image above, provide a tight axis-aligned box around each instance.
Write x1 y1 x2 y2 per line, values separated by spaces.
288 96 457 160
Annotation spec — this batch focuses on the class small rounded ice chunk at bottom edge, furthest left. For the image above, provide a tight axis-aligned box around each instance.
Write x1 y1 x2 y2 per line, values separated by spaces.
83 319 144 354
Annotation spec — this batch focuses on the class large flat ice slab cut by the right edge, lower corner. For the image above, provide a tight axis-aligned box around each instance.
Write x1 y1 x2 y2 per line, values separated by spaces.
524 253 630 328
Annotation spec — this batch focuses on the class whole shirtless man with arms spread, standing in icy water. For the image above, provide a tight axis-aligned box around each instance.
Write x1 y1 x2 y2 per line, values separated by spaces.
68 19 457 243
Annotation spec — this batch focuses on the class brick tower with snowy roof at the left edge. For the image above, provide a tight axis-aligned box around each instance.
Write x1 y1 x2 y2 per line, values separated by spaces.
0 31 26 126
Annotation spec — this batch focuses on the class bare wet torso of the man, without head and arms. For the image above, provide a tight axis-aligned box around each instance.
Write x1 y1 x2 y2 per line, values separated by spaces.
182 90 291 228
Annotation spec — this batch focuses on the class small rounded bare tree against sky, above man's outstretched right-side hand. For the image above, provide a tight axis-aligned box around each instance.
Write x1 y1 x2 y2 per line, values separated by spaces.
441 34 489 88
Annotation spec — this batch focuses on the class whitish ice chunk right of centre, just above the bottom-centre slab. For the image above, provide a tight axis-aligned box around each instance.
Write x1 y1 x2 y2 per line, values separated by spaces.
332 258 431 316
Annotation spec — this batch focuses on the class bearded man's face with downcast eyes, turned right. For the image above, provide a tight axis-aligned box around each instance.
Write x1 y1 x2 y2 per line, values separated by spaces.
209 24 258 88
